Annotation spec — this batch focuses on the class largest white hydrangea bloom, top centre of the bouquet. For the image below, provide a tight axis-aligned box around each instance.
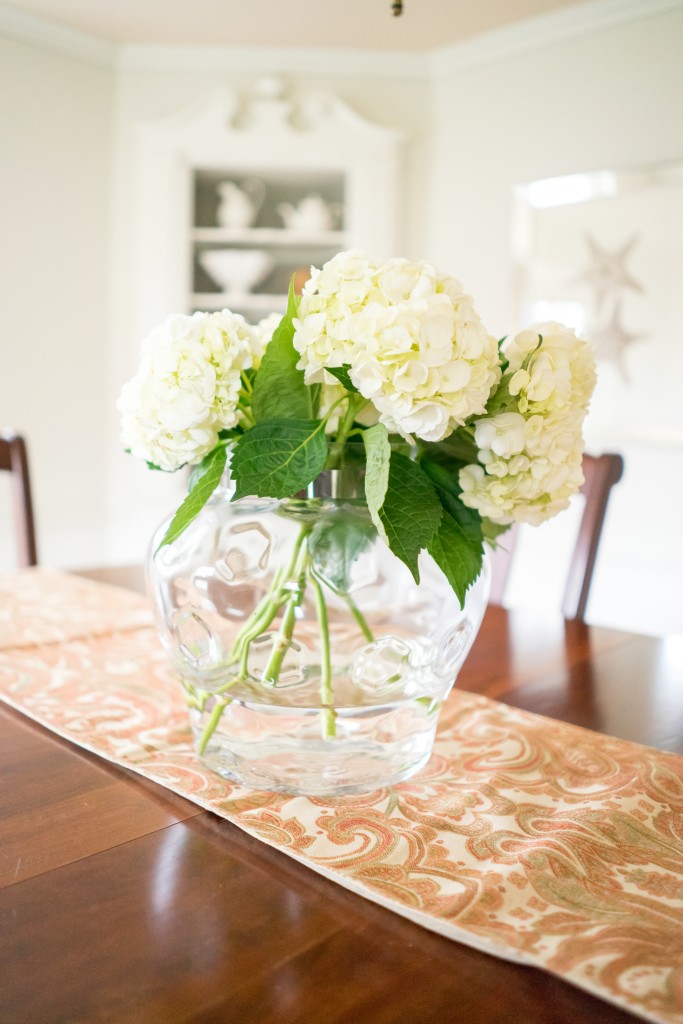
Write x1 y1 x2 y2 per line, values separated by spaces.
294 252 500 441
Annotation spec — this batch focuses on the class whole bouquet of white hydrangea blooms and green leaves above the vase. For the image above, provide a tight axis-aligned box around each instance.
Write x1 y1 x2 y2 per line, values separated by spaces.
119 252 595 603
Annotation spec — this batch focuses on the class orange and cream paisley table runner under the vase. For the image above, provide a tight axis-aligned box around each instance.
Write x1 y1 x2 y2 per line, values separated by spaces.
0 569 683 1024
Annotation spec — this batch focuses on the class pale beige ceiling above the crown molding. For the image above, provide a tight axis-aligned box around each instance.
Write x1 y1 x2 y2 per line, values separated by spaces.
4 0 589 53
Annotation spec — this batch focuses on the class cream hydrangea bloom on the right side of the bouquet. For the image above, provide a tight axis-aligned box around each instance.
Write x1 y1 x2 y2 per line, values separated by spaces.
460 323 595 525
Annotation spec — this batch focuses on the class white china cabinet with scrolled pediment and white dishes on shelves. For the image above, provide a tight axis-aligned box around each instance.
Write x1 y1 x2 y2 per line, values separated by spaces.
136 79 401 333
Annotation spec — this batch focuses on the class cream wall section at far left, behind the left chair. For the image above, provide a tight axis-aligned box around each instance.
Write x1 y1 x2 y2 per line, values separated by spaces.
0 37 114 567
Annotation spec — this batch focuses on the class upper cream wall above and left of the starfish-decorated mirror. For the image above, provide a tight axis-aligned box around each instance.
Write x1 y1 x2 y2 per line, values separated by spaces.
428 9 683 325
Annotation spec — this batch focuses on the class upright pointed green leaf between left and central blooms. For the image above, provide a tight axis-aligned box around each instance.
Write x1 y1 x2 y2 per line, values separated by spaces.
252 282 313 423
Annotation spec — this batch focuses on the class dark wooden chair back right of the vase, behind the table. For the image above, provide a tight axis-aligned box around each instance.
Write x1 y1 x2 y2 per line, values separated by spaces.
490 453 624 620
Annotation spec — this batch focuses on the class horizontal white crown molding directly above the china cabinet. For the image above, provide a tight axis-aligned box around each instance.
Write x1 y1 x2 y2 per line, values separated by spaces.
119 45 429 79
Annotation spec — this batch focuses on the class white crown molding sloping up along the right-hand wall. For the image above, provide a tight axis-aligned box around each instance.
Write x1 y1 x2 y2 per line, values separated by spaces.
429 0 683 79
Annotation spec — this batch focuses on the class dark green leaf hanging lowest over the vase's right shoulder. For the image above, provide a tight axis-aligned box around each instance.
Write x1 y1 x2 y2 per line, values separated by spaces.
423 461 483 607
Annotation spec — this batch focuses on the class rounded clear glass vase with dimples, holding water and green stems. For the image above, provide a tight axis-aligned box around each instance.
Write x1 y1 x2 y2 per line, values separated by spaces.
147 460 489 796
